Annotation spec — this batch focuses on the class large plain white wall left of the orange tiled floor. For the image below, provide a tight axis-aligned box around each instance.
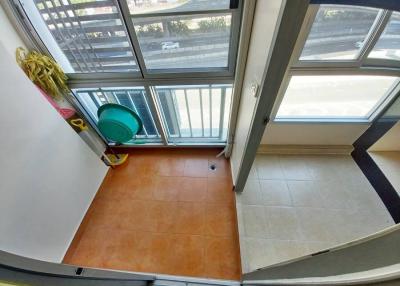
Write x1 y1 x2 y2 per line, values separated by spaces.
0 9 107 262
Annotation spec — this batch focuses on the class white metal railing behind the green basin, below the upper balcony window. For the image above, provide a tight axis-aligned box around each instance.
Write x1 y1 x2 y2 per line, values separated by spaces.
74 85 232 144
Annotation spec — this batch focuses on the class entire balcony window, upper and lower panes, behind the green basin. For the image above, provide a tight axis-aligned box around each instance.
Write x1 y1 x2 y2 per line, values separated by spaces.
13 0 243 145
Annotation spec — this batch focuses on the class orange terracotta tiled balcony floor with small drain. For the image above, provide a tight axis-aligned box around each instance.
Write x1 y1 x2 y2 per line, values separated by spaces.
64 149 241 280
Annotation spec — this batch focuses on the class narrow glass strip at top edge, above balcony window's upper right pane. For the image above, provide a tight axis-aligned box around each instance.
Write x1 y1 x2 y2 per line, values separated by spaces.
128 0 230 14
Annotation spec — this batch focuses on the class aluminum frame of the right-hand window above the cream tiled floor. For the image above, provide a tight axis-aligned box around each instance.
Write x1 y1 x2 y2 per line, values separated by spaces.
271 4 400 124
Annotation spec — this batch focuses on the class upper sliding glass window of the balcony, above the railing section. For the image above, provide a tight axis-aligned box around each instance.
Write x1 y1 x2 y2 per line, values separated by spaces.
16 0 240 77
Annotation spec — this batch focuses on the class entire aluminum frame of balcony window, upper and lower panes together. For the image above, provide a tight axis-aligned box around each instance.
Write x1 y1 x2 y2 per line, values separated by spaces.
6 0 244 148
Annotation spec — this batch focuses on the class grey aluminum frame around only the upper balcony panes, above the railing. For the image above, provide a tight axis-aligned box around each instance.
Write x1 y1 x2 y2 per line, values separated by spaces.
10 0 243 80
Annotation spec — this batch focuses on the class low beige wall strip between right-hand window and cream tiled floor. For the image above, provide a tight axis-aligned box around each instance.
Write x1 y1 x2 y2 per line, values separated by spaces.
261 123 369 145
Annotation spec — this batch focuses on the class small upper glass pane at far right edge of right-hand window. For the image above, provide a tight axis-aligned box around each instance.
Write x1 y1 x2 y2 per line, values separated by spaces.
368 12 400 61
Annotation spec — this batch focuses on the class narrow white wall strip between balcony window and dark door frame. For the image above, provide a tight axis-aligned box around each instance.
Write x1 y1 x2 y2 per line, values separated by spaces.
230 0 282 182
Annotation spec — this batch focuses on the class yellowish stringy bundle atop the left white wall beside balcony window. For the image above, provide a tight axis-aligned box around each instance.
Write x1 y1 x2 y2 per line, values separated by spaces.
16 47 69 99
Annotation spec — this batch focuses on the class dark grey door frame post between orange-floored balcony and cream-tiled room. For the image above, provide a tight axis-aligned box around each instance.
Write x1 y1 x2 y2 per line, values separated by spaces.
234 0 310 192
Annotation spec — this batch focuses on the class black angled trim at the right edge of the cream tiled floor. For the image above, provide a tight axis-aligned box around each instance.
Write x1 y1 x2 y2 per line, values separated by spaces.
351 120 400 223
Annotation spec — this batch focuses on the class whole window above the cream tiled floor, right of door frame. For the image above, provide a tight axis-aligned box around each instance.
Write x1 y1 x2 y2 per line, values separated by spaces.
273 5 400 122
